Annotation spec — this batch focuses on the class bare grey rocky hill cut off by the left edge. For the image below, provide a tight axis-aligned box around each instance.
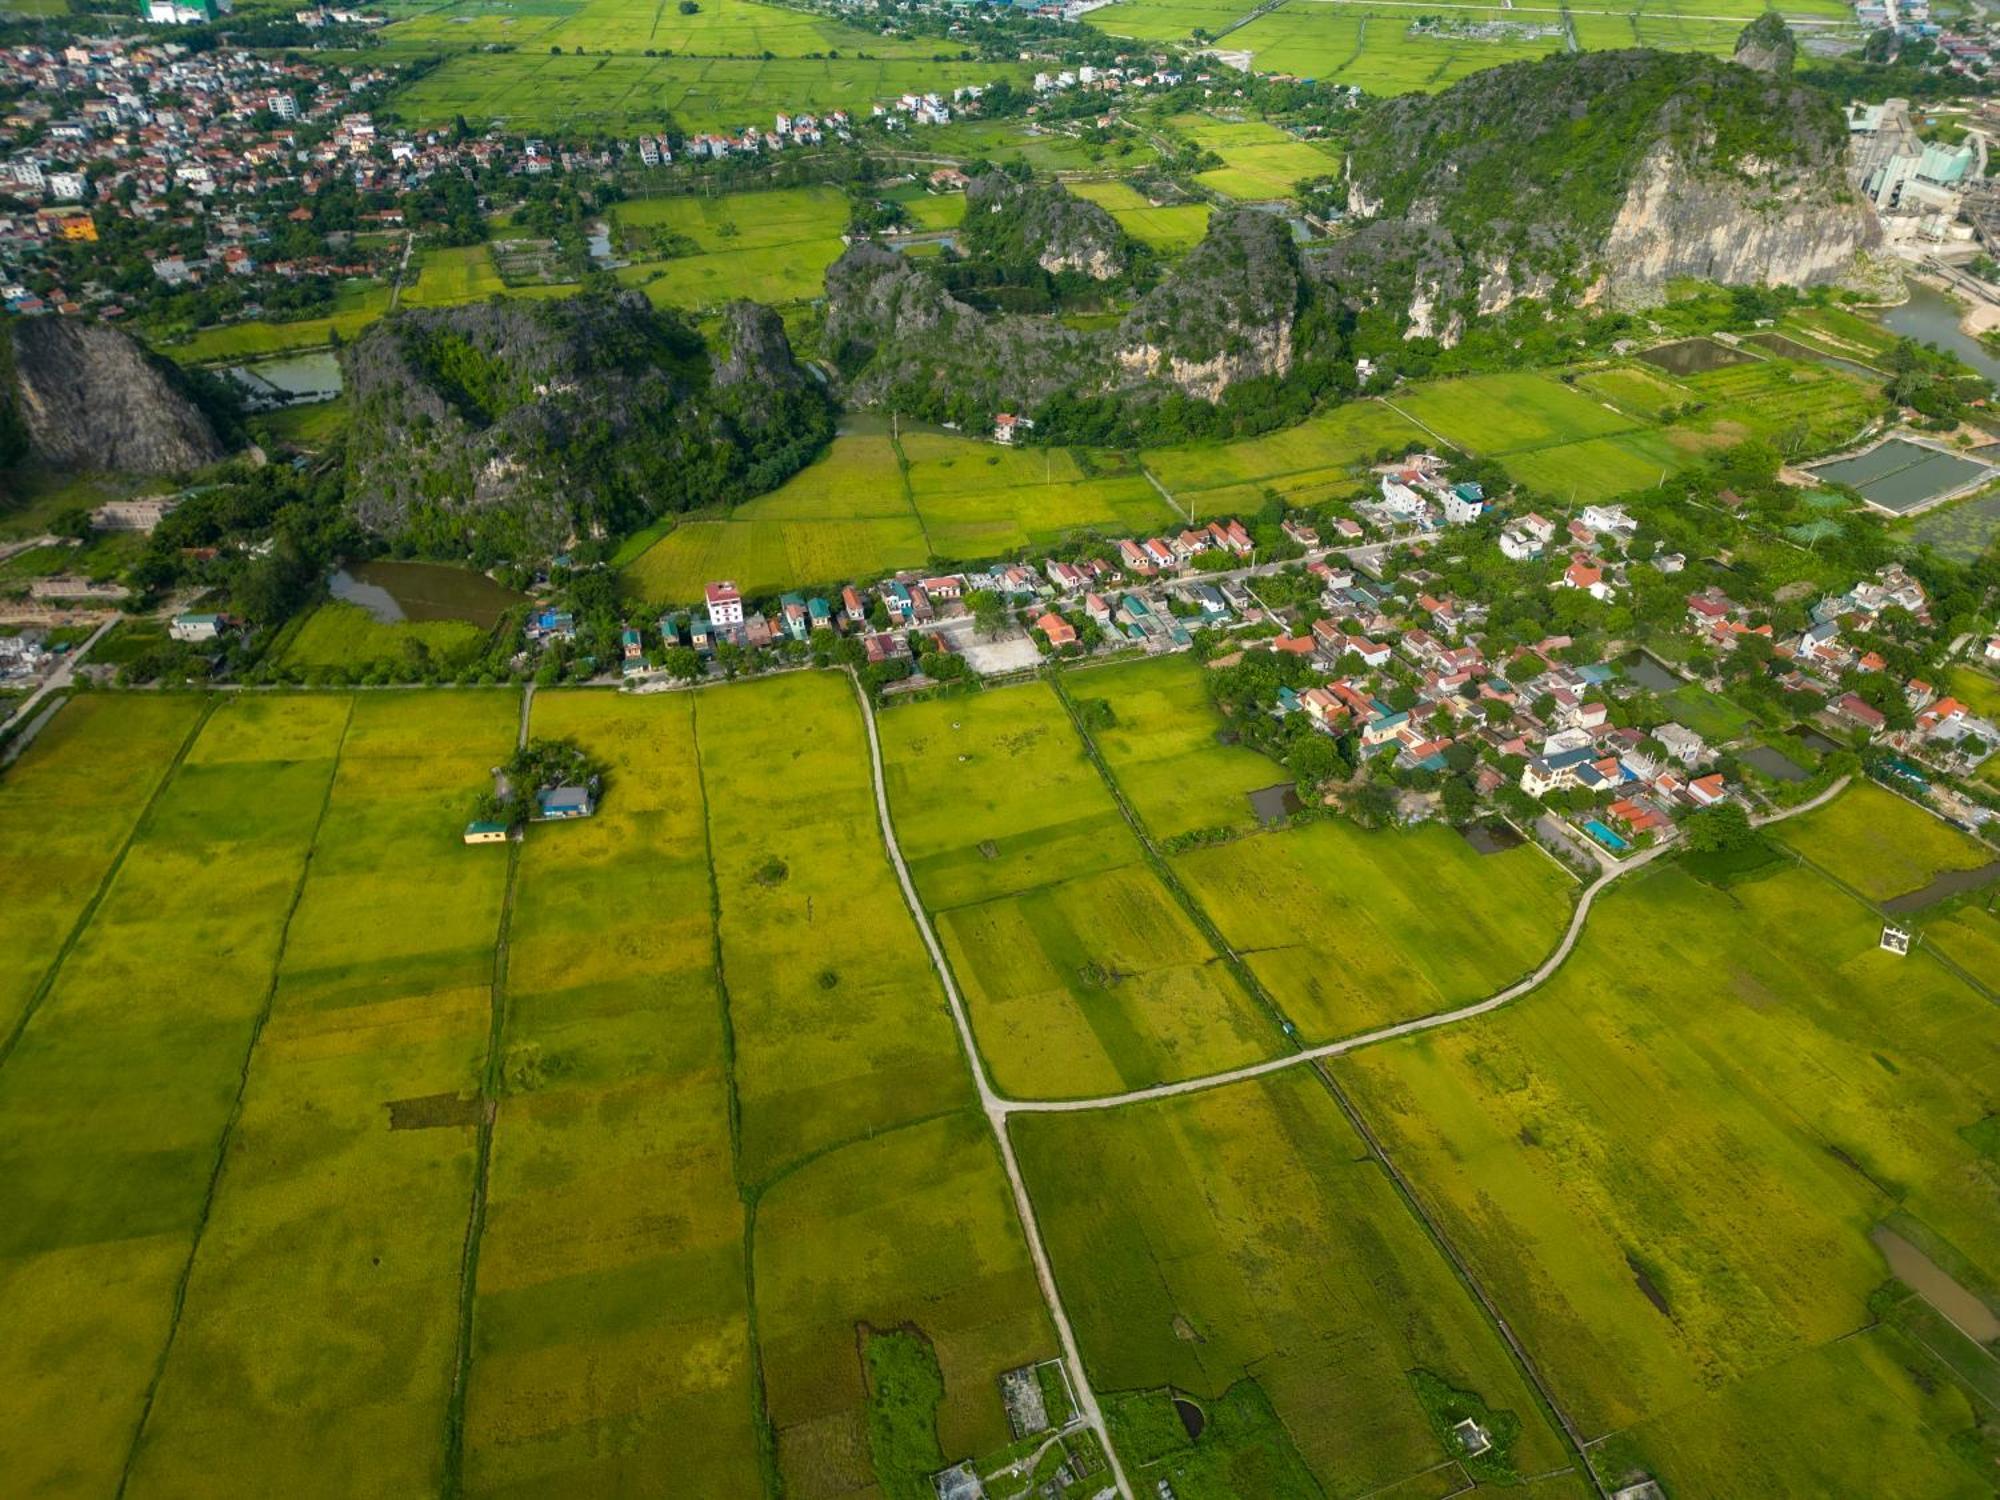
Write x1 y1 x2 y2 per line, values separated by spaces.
0 318 224 474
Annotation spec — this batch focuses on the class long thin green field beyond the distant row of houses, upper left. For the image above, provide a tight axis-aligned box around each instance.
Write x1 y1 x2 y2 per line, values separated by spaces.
394 44 1026 134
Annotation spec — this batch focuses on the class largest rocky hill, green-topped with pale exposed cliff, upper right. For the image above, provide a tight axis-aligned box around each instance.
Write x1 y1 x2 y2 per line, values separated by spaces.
1316 48 1880 342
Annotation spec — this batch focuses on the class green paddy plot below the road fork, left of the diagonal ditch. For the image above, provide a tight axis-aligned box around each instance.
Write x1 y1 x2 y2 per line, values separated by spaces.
1012 1070 1566 1496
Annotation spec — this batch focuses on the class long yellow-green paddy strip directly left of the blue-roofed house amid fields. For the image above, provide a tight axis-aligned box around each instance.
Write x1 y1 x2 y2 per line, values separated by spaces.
128 692 520 1496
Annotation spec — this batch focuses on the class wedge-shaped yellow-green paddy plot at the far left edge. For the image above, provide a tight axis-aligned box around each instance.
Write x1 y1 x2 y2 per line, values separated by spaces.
0 694 200 1036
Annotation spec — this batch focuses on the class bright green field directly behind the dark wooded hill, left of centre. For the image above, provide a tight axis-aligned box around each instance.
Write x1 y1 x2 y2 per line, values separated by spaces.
612 188 848 308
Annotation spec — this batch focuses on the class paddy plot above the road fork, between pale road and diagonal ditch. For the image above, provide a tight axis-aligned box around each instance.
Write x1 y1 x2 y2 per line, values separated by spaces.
882 682 1278 1098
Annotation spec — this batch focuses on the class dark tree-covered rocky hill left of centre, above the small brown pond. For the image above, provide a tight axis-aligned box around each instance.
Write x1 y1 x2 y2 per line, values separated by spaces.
346 292 832 558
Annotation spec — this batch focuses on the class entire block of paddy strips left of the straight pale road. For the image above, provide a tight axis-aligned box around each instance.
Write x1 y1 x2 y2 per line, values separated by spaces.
0 676 1056 1496
